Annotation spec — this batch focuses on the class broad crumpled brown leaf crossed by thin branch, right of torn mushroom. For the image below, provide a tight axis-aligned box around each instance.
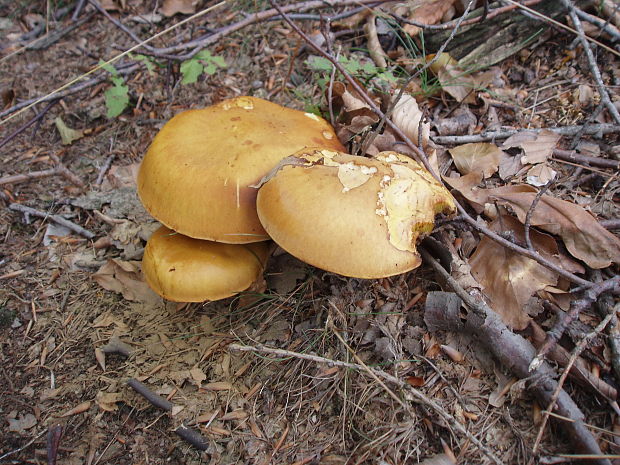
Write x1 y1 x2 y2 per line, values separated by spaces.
469 215 559 330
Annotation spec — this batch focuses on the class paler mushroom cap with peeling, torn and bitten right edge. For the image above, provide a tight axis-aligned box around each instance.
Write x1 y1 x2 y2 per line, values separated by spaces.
257 149 455 278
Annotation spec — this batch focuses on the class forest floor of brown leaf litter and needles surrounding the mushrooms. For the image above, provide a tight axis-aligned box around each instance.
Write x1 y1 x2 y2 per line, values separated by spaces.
0 0 620 465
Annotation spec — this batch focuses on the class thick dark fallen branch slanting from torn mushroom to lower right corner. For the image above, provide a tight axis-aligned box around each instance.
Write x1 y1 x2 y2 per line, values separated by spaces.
420 247 611 465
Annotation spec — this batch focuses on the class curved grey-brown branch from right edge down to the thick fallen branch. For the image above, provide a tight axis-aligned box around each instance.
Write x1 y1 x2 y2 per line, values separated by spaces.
530 276 620 370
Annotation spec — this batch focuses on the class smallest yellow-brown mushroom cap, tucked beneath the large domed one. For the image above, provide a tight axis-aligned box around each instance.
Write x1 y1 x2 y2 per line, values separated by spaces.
142 226 269 302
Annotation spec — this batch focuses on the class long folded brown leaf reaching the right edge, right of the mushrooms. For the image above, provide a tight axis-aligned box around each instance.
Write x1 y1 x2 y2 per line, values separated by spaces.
489 186 620 269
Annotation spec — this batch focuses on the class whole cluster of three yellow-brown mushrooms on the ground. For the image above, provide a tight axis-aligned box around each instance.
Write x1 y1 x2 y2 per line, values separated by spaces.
138 97 455 302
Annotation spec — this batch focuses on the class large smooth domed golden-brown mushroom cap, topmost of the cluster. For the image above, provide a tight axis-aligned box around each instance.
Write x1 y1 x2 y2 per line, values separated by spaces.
138 97 344 244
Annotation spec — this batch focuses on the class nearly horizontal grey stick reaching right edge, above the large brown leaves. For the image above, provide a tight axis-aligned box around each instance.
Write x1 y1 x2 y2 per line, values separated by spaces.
431 124 620 145
